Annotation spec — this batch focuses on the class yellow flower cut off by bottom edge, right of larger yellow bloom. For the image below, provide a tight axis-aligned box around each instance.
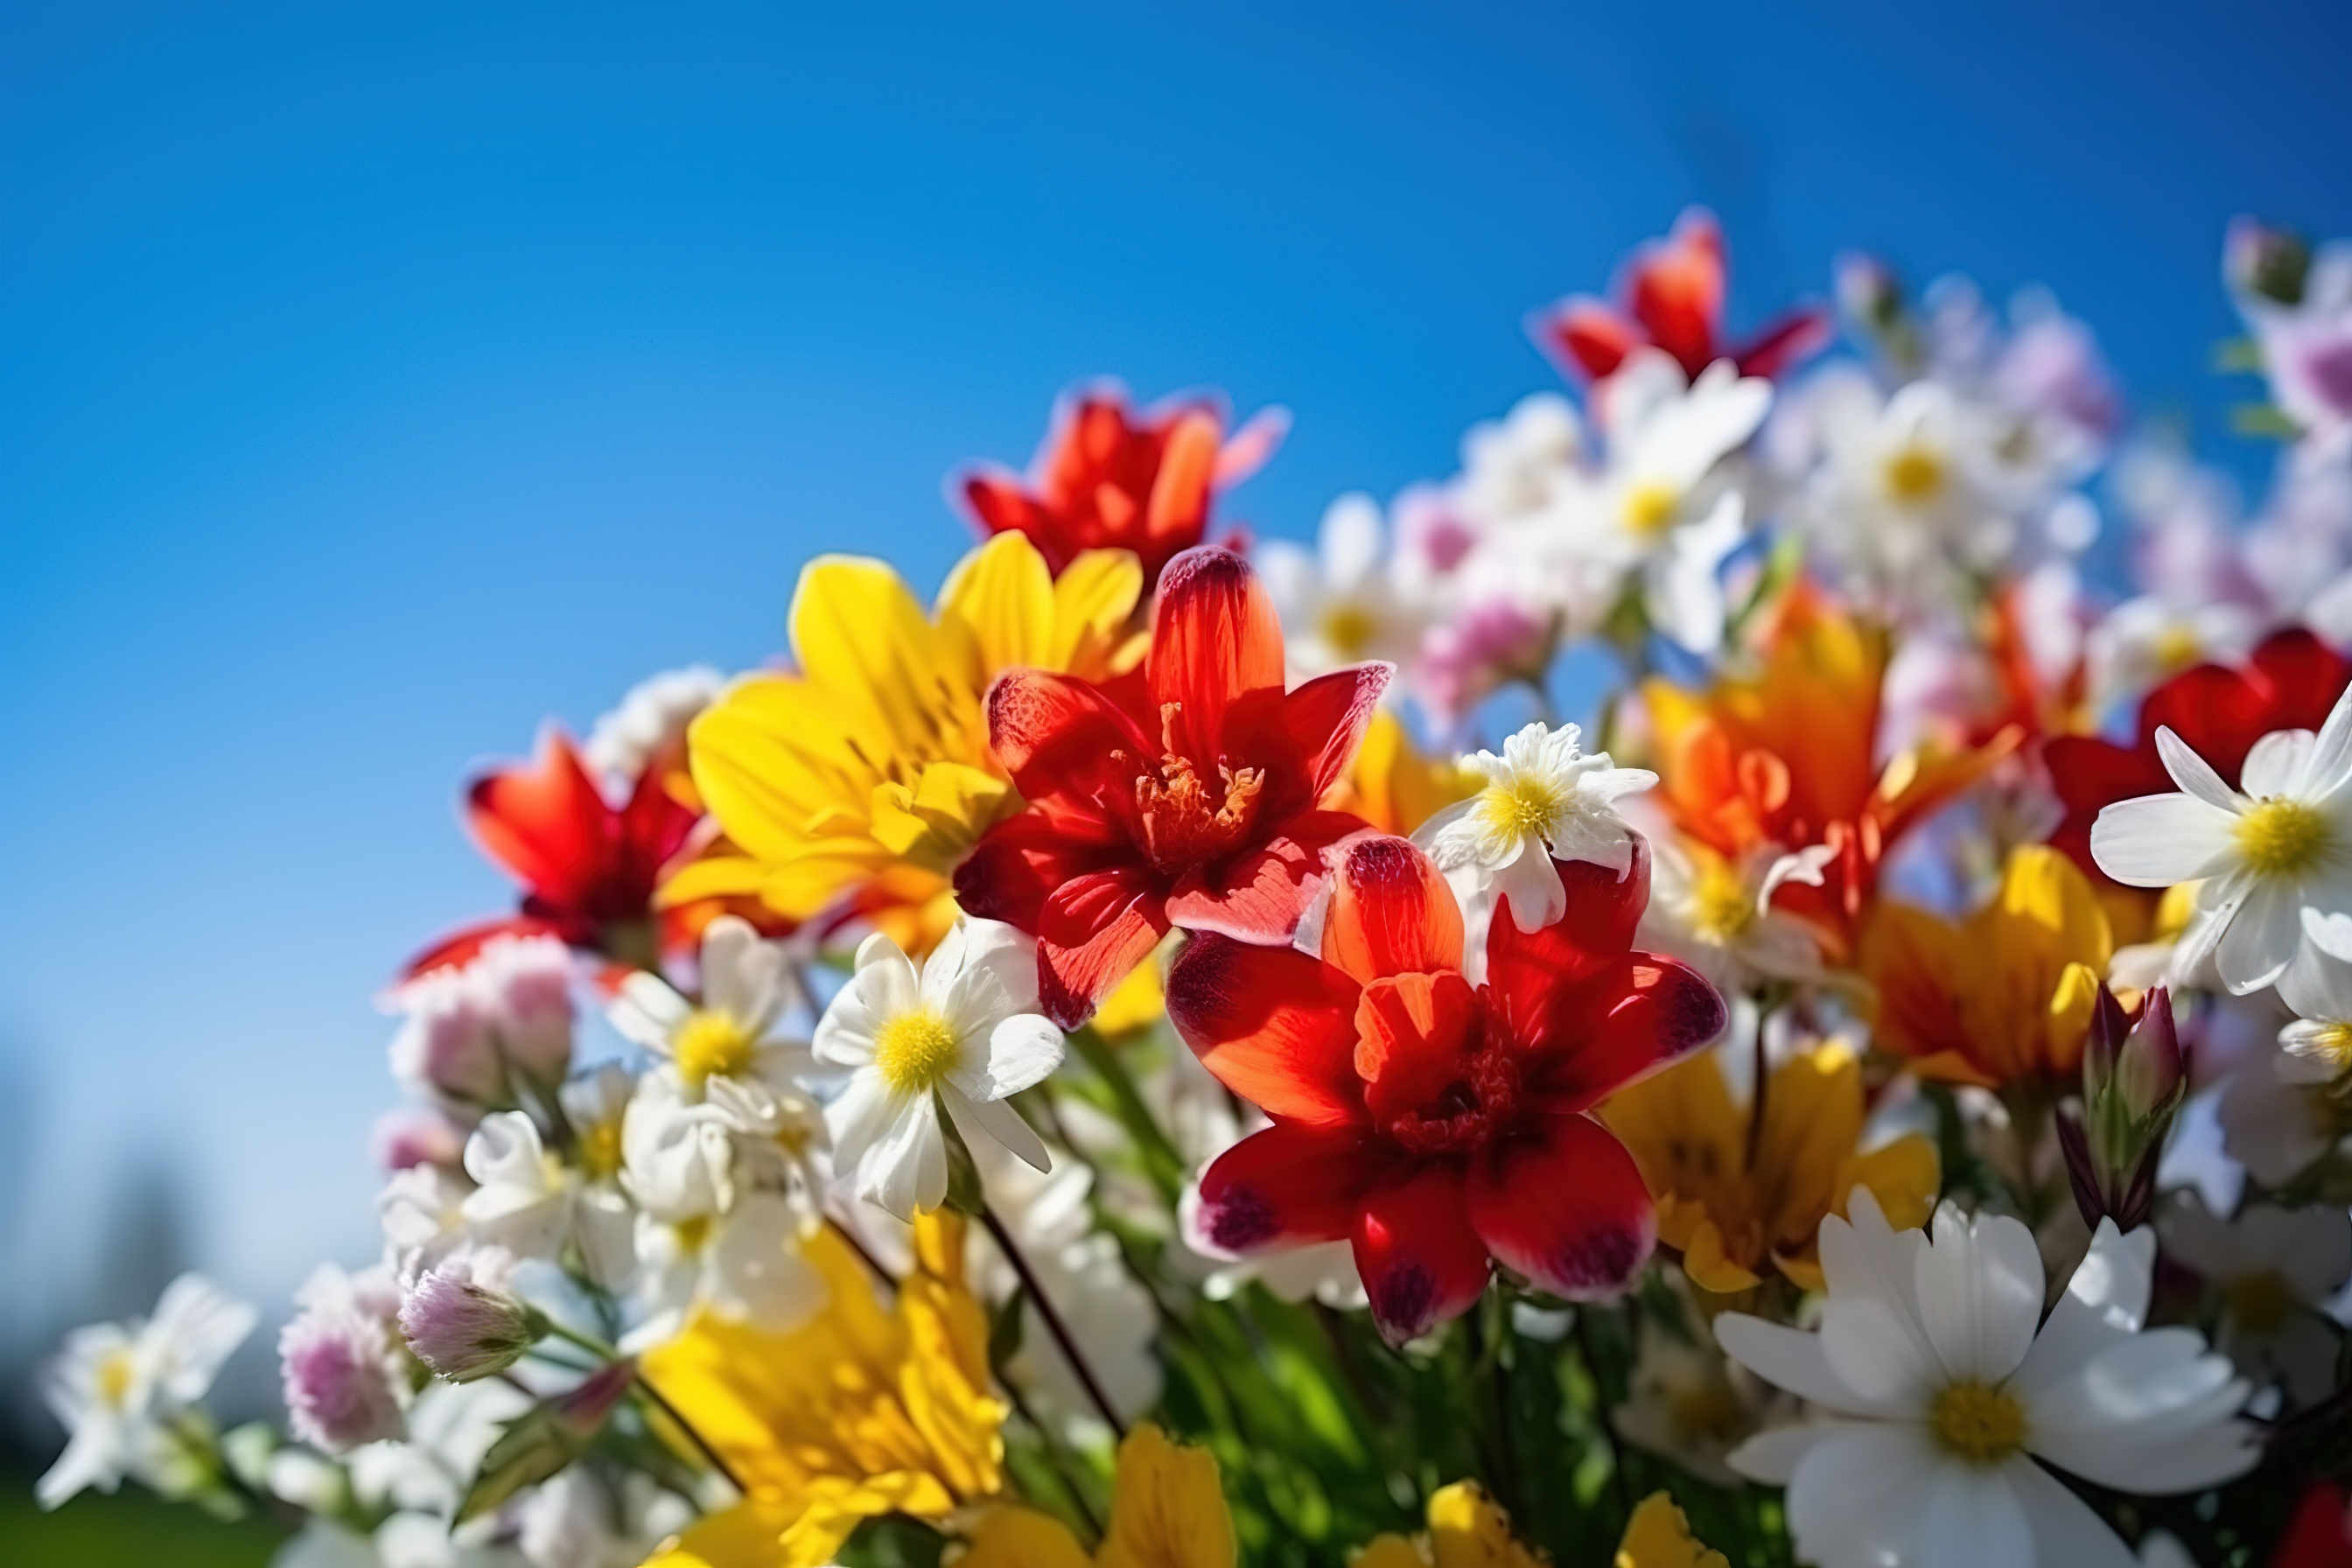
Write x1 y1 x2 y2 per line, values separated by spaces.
957 1427 1235 1568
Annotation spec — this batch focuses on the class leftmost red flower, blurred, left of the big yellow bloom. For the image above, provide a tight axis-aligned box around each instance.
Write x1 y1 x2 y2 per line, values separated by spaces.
407 726 701 976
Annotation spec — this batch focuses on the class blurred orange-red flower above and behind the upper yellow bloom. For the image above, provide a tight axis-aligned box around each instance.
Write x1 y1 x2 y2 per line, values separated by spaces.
964 386 1289 583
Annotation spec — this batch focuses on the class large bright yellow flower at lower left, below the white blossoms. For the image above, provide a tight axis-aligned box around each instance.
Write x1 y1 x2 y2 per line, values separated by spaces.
645 1215 1004 1568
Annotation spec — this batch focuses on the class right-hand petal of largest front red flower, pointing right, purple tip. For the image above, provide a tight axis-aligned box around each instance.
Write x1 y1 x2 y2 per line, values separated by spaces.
1523 952 1729 1112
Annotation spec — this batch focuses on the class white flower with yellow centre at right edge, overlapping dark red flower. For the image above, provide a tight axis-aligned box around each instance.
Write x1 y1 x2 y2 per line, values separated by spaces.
2091 698 2352 994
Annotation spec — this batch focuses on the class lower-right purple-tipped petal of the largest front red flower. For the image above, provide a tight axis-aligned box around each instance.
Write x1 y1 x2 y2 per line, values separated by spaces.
1467 1116 1658 1300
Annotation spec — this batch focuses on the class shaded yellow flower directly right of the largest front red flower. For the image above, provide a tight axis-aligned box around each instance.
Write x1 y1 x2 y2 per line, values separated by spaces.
1602 1044 1938 1295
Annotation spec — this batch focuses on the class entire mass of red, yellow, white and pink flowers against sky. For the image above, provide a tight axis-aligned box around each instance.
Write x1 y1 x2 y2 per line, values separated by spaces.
42 212 2352 1568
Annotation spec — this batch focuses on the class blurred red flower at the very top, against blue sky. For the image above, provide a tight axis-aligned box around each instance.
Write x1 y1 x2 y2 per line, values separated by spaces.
1527 206 1830 381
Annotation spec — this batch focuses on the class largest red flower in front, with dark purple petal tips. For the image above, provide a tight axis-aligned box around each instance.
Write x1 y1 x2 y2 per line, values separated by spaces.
1166 835 1724 1345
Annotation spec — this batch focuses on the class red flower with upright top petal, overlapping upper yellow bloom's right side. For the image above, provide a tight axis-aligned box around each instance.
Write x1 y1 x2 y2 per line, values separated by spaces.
955 545 1390 1030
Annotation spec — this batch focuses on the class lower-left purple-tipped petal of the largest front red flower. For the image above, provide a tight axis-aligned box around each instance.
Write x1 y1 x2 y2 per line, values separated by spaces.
1195 1124 1381 1253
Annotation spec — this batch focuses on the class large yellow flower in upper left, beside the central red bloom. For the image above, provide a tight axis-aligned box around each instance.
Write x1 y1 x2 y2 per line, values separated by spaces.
661 534 1143 952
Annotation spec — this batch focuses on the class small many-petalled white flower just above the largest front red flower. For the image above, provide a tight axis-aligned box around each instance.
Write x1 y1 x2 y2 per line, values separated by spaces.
1413 724 1658 955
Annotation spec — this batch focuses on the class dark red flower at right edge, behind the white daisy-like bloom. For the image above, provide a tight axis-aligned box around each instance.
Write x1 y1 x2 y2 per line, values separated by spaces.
2041 627 2352 881
